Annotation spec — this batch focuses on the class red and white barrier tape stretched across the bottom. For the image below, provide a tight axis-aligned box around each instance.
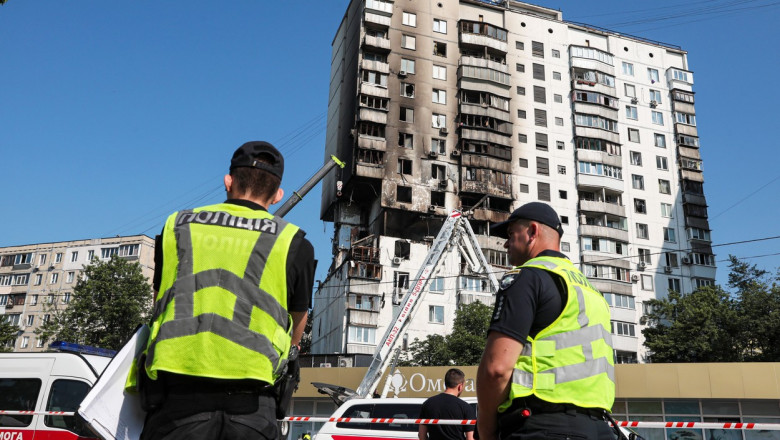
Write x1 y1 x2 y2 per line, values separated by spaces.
0 410 780 431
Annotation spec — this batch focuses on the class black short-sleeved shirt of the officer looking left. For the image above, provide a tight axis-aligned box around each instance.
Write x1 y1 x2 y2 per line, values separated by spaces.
488 250 567 344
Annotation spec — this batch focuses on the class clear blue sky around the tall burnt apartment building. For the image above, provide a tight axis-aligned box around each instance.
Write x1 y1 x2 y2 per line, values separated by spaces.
0 0 780 283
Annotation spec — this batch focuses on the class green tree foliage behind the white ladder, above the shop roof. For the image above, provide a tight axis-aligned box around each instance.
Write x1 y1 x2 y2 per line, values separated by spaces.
400 302 492 367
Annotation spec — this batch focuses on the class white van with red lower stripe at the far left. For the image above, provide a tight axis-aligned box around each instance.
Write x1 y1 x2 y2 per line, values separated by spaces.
0 352 111 440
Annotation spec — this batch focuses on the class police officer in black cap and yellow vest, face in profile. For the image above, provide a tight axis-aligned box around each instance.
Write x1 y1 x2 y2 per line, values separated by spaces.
477 202 615 440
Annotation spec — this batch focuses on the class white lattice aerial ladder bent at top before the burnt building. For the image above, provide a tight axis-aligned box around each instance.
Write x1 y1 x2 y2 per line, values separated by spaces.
313 211 498 404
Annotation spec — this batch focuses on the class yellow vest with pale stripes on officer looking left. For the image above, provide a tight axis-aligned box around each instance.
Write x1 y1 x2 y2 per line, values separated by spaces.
498 257 615 412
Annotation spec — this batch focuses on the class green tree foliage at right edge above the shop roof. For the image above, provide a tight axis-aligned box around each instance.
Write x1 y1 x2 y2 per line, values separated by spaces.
642 256 780 362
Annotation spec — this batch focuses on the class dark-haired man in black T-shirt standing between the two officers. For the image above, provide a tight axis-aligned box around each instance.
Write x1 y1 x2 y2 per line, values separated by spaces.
417 368 476 440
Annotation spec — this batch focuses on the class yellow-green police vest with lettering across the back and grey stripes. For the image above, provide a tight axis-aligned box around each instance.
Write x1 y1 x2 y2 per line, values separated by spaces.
140 203 299 383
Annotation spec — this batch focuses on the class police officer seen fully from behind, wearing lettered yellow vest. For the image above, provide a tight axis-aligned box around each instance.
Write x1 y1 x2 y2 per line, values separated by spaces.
141 142 315 440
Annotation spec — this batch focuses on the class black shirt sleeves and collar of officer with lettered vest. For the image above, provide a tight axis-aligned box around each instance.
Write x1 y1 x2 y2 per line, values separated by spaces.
152 199 316 312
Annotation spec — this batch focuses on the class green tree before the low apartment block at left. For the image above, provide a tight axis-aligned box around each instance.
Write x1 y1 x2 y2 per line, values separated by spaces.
36 256 152 350
